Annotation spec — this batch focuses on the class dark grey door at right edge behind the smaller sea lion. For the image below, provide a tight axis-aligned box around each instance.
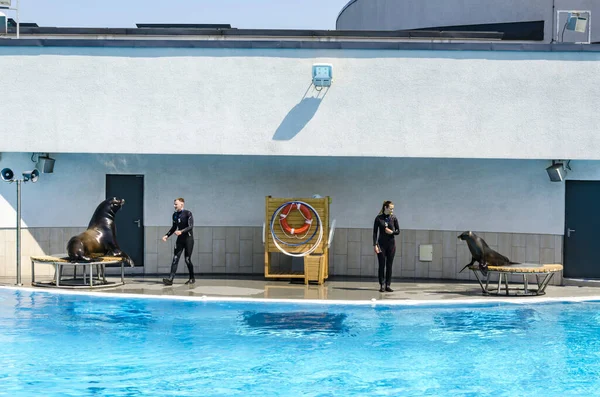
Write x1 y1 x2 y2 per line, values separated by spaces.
564 181 600 278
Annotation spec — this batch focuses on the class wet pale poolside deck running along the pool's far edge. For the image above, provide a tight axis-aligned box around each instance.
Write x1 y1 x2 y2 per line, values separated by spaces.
0 276 600 303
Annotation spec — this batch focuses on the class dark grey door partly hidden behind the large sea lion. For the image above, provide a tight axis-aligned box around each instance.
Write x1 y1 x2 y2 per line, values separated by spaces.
106 175 144 266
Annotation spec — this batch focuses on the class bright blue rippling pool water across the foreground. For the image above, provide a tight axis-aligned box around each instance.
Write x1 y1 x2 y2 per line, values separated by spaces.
0 289 600 397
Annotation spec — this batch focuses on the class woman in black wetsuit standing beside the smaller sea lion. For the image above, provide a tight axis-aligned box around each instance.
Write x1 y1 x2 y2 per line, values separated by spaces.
373 201 400 292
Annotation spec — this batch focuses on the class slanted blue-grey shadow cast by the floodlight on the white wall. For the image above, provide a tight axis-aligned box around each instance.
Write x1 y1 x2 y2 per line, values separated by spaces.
273 84 328 141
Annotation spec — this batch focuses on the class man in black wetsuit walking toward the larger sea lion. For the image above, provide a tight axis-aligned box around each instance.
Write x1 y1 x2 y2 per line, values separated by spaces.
163 197 196 285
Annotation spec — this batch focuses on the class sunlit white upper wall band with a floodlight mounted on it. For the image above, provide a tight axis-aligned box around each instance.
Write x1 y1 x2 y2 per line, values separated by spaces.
0 47 600 159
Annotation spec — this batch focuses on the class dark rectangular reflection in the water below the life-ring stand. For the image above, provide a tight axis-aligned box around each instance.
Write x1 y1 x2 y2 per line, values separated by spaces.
242 311 348 335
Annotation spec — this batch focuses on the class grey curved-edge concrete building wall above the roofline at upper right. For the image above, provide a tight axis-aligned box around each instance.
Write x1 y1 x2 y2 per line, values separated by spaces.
336 0 600 43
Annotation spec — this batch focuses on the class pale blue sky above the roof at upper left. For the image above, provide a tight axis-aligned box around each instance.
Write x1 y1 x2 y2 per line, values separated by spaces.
5 0 349 30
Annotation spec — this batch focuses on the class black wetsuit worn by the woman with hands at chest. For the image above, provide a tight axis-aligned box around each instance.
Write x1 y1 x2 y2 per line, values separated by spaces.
373 214 400 287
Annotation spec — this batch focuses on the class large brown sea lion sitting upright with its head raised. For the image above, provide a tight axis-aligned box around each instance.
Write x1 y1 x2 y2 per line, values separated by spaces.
67 197 134 267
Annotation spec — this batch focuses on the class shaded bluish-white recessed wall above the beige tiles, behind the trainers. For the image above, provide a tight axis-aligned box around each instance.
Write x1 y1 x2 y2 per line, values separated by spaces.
0 153 600 234
